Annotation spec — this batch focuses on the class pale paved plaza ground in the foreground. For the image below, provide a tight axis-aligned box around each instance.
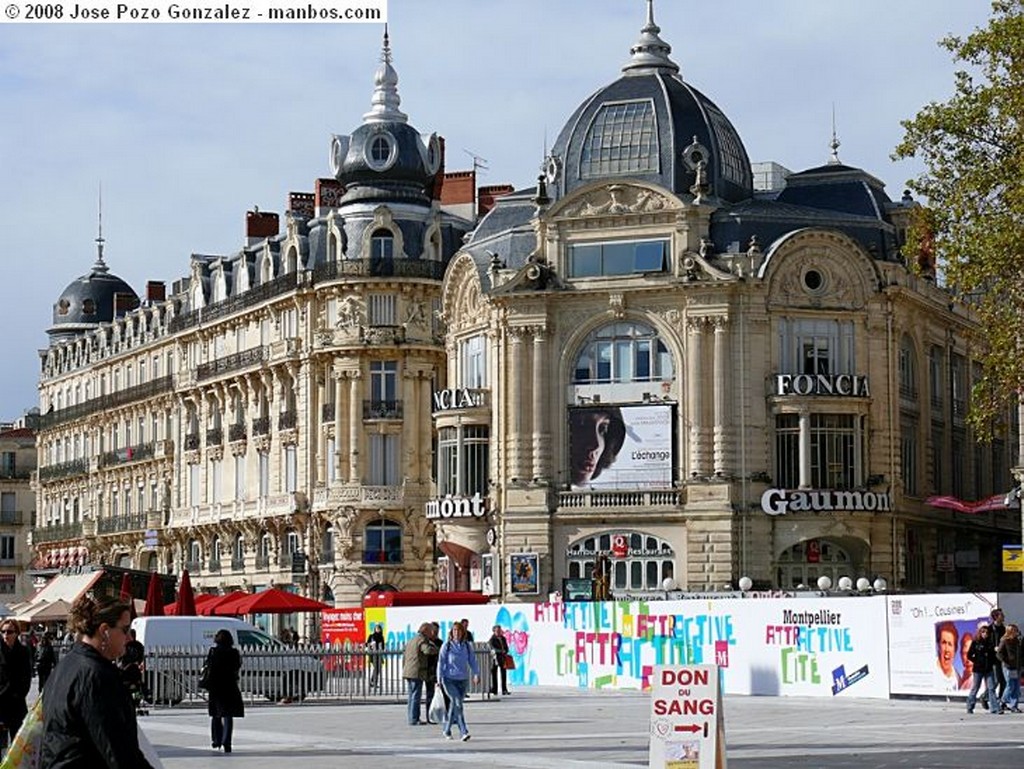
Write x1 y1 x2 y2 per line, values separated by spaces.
140 687 1024 769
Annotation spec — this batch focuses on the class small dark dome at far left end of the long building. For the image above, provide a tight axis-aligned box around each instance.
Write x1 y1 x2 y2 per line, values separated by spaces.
46 234 138 342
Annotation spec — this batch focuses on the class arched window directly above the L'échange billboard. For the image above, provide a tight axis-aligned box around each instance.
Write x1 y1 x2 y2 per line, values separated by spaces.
572 323 675 384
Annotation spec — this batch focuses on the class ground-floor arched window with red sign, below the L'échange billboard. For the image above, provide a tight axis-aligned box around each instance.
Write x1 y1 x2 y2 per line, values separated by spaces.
566 531 676 592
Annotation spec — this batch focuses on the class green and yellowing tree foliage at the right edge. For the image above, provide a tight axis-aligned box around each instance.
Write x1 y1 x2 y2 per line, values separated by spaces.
894 0 1024 435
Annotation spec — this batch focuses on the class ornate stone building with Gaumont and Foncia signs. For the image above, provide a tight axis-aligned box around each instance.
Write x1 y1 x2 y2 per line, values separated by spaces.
434 4 1020 600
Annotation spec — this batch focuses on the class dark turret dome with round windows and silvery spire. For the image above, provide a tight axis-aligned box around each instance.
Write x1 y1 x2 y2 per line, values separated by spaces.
331 28 441 203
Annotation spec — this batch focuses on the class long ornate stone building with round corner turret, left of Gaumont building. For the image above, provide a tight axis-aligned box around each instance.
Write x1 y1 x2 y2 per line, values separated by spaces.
35 35 472 605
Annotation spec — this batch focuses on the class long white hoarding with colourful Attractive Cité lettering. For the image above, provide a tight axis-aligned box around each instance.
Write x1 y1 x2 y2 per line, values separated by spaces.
386 596 889 698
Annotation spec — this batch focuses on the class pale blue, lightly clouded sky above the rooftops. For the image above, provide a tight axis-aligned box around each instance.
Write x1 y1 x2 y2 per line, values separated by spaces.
0 0 990 420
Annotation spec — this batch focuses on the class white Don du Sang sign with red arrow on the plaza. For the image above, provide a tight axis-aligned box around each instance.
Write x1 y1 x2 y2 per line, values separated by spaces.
649 665 726 769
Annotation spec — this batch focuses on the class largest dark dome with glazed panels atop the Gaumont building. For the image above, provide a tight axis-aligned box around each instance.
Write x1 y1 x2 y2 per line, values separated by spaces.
545 0 754 202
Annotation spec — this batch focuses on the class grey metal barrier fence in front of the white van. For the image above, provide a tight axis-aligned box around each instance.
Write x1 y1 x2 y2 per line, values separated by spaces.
138 644 490 707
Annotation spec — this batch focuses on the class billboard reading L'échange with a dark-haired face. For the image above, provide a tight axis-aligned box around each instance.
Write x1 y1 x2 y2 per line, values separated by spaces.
568 403 673 490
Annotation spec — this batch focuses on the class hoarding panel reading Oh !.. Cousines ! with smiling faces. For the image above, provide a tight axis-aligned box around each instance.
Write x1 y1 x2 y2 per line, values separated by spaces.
887 593 995 697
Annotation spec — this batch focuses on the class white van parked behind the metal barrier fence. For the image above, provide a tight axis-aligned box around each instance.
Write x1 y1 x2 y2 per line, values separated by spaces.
131 616 324 703
